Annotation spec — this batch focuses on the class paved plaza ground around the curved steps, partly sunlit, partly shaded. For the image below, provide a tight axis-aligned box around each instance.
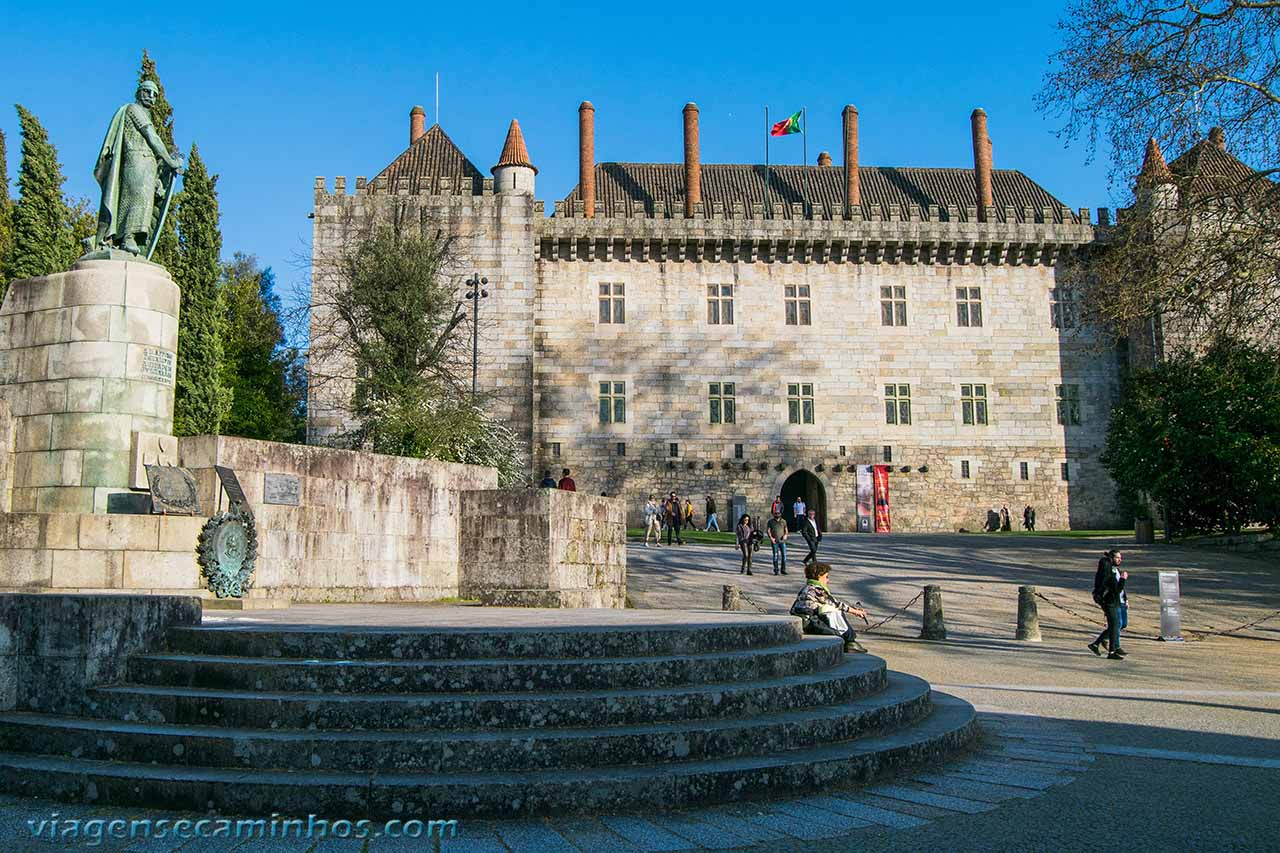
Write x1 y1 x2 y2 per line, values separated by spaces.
0 534 1280 853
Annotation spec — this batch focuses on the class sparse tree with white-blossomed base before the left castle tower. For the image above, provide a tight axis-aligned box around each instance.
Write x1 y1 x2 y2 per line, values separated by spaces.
312 227 522 484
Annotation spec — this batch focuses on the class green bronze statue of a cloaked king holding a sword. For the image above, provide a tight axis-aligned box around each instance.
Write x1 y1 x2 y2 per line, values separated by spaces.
86 81 182 260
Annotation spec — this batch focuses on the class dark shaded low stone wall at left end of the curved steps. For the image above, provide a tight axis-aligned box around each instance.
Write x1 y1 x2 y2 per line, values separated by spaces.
0 596 201 715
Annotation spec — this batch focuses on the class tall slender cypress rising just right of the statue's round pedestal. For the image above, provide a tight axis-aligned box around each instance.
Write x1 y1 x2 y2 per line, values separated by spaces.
170 145 232 435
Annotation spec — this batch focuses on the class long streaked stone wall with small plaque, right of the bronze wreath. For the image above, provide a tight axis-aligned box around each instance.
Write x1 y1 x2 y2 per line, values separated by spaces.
179 435 498 601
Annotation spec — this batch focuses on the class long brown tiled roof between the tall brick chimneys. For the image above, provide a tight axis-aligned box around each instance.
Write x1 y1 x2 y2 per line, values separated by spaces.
566 163 1064 222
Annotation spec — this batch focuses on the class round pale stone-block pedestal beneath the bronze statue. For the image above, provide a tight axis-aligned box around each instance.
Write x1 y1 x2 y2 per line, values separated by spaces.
0 260 179 512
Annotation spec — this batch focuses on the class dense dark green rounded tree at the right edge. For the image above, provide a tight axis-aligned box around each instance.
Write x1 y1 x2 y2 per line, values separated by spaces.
1102 341 1280 533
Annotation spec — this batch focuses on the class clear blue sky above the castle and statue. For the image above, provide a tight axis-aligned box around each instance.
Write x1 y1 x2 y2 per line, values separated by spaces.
0 0 1117 306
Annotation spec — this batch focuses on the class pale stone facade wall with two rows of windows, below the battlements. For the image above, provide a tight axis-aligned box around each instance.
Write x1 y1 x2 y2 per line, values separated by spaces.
535 252 1117 530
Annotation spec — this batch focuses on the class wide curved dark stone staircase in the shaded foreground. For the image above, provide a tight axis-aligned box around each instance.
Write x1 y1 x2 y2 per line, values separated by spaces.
0 613 977 818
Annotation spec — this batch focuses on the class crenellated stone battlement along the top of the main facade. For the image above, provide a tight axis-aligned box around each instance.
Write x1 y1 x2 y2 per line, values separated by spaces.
536 202 1106 265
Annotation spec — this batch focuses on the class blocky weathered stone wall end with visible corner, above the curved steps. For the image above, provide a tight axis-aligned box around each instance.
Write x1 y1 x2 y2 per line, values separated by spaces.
460 489 626 607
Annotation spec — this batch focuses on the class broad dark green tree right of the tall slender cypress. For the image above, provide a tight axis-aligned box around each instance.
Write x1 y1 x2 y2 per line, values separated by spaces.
223 252 306 443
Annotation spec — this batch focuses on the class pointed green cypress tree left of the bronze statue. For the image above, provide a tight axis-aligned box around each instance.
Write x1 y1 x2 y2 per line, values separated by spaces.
8 104 81 278
